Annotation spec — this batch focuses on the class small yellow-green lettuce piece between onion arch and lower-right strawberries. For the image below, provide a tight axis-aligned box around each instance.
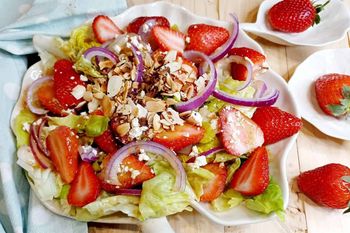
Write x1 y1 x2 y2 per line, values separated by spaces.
186 166 215 200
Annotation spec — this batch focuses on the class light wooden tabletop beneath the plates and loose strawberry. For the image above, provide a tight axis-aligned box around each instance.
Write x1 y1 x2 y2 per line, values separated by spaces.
89 0 350 233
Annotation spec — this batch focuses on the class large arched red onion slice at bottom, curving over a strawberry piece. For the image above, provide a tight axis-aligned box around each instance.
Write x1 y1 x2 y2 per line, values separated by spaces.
105 141 186 191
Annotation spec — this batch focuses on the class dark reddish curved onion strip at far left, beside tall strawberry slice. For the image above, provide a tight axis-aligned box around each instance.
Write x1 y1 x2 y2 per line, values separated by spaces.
29 123 52 169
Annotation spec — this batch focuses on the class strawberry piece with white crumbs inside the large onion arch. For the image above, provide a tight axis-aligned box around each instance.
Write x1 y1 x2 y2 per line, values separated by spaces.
118 155 154 188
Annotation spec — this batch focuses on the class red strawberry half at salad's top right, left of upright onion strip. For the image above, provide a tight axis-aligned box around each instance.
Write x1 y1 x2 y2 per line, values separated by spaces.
186 24 230 55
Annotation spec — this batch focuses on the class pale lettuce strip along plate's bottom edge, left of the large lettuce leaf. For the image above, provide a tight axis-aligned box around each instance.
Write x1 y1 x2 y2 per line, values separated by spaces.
82 195 141 219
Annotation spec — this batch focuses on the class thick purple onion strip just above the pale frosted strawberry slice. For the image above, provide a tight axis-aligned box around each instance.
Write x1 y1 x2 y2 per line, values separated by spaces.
213 89 279 107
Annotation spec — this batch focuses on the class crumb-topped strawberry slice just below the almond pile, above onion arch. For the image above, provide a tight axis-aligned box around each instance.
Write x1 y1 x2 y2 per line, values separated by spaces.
153 124 204 151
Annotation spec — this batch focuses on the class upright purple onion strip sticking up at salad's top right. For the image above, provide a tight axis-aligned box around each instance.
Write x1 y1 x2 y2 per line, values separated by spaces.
209 13 239 62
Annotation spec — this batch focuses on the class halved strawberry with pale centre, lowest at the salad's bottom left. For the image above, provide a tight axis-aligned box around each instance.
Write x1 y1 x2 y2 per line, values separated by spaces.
67 162 101 207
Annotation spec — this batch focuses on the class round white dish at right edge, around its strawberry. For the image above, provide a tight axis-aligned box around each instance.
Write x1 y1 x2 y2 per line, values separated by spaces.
288 49 350 140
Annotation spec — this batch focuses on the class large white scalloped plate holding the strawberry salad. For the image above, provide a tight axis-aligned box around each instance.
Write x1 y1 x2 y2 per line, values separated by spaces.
12 2 299 225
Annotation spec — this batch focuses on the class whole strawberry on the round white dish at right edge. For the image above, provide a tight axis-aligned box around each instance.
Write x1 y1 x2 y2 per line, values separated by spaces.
315 74 350 117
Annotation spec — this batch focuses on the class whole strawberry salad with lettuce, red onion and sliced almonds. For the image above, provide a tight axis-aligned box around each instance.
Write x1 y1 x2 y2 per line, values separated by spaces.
14 15 302 221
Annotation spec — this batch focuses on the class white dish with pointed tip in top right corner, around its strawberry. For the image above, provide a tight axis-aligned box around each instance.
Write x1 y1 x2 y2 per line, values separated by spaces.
241 0 350 46
